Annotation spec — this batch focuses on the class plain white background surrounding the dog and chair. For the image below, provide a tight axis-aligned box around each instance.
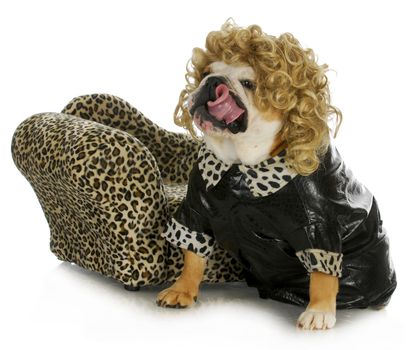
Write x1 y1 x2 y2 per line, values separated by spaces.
0 0 419 349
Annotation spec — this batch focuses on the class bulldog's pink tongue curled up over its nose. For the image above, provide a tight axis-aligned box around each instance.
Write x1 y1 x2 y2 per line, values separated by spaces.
207 84 244 124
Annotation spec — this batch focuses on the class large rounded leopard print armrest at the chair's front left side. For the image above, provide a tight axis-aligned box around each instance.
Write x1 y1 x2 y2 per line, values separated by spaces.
12 113 169 286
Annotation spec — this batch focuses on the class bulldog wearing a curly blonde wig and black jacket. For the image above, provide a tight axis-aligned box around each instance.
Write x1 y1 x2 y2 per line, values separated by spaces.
157 23 396 329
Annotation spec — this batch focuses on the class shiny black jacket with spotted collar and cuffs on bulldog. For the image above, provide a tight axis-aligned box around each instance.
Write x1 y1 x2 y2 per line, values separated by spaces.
163 144 396 308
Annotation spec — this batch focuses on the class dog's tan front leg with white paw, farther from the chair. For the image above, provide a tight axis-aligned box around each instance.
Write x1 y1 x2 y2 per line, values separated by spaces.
297 272 339 329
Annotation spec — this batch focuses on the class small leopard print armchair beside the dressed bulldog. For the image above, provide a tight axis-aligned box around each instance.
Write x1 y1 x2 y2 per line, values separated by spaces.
12 94 243 290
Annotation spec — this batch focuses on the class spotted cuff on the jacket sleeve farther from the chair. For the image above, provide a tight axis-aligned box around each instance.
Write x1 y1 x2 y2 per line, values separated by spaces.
296 249 343 277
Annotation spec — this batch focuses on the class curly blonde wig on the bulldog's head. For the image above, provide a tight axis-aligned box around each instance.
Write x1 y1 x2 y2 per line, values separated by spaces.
174 20 342 175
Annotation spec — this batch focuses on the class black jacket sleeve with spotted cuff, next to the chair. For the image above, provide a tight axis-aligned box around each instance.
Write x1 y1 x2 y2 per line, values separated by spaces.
159 163 215 257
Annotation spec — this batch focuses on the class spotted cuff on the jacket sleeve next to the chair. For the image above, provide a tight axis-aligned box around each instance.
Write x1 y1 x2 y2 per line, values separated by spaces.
162 218 215 258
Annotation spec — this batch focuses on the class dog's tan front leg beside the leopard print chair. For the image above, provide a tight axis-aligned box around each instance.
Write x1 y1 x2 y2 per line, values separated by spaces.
157 249 206 308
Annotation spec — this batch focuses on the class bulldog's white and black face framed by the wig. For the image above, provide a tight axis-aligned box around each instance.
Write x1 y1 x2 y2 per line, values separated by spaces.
188 61 282 164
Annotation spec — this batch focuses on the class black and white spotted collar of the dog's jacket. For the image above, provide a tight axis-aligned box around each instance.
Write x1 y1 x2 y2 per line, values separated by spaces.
198 142 297 197
